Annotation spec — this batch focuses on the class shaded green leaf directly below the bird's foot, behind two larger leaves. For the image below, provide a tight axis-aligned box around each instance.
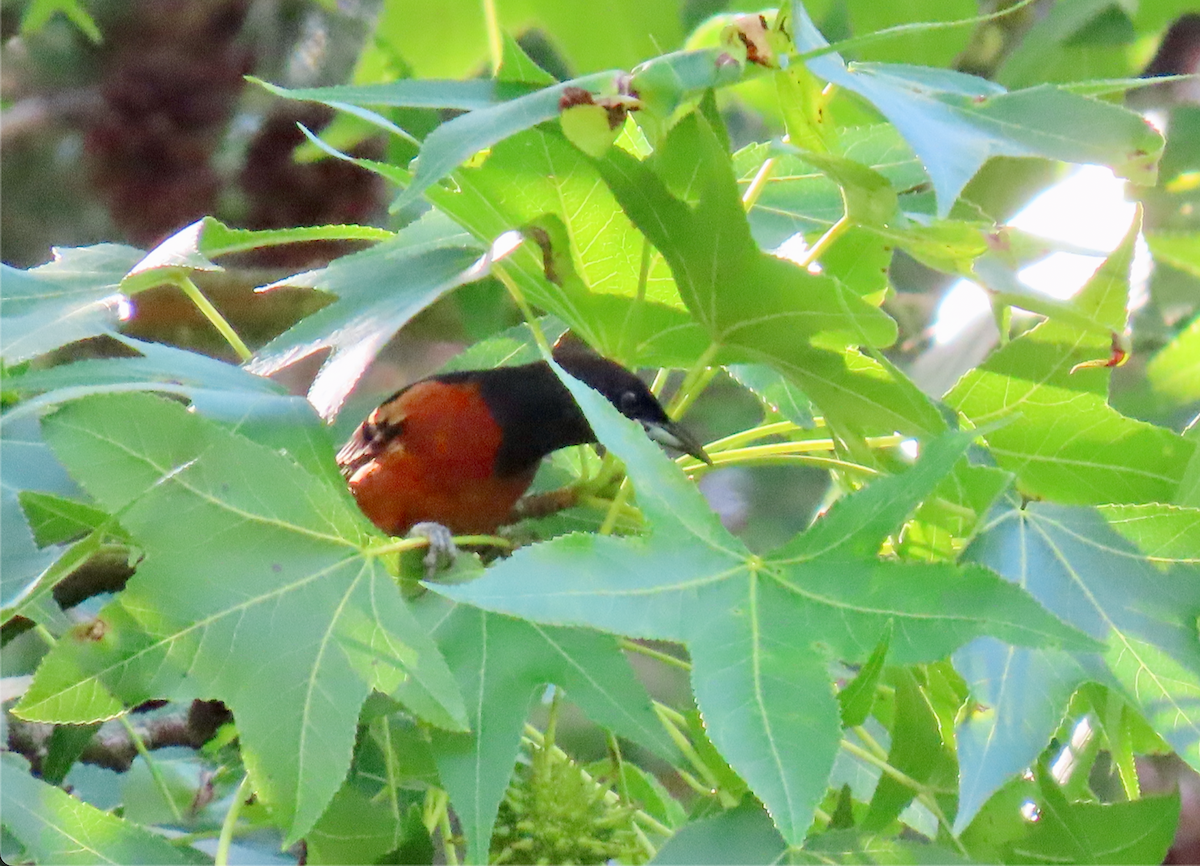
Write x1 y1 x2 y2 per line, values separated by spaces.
412 596 676 862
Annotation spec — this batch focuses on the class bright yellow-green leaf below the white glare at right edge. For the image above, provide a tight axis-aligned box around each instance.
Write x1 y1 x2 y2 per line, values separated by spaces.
946 211 1195 504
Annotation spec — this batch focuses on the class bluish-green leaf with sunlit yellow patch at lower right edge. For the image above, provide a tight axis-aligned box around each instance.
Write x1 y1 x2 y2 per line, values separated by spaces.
954 503 1200 831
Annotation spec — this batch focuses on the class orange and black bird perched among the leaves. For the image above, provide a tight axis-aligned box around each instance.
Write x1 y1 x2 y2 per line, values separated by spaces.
337 332 712 542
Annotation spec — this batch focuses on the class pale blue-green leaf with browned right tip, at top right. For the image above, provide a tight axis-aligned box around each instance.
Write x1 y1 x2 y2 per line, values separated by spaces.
792 2 1163 216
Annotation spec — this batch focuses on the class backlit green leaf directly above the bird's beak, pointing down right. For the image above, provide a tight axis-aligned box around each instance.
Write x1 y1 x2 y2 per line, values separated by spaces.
596 113 944 434
